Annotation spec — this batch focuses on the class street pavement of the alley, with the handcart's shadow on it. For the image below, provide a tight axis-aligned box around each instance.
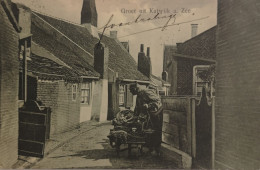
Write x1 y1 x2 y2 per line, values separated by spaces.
31 123 177 169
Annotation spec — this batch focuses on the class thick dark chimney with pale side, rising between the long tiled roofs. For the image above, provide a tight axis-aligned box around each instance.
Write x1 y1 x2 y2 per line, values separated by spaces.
94 43 109 79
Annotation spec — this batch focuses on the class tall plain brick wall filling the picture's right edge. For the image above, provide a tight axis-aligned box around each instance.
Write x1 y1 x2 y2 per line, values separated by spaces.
214 0 260 169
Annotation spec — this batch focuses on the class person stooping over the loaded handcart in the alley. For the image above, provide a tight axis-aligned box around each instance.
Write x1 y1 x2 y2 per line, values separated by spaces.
130 84 162 155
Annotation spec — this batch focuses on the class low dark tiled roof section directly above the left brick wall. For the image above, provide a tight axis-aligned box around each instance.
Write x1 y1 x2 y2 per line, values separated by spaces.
27 53 79 80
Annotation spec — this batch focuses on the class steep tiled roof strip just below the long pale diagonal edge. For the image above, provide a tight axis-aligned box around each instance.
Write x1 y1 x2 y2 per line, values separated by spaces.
32 15 99 77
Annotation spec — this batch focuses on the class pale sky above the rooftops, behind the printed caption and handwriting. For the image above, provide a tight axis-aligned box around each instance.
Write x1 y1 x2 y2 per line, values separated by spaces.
12 0 217 76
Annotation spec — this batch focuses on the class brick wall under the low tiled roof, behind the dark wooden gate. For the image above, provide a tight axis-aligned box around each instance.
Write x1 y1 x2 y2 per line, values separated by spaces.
37 81 80 136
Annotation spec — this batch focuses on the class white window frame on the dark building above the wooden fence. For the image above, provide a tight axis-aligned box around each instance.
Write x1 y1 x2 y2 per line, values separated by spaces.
193 65 212 96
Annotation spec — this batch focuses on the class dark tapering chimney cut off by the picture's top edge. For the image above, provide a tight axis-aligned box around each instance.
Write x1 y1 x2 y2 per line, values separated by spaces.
81 0 98 27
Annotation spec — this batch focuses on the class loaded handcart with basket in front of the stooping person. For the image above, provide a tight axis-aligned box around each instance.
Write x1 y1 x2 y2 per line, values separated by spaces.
108 110 159 156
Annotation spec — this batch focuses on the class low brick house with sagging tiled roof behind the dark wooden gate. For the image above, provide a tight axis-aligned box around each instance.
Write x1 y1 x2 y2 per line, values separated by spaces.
27 51 98 135
